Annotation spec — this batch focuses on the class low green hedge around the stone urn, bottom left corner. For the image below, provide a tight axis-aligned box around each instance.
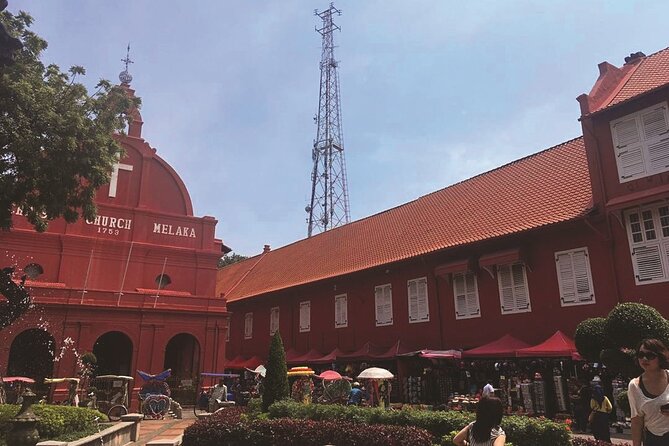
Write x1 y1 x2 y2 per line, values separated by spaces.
0 404 107 440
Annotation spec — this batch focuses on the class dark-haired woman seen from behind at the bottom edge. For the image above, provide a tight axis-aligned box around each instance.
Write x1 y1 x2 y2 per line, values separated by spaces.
453 396 506 446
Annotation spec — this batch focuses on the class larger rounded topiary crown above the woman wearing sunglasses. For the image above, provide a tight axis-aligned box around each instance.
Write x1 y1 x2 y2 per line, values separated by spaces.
604 302 669 348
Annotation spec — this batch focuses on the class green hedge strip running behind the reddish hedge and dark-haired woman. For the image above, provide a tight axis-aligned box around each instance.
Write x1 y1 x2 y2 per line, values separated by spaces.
269 401 570 446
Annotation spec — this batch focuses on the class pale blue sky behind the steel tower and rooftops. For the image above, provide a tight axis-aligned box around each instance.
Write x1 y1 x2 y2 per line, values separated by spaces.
8 0 669 255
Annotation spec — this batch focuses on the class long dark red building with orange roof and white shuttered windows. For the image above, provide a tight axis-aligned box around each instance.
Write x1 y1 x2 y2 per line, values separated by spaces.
217 49 669 392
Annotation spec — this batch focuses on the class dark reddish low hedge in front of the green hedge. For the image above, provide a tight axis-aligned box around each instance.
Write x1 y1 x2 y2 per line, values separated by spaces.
183 408 434 446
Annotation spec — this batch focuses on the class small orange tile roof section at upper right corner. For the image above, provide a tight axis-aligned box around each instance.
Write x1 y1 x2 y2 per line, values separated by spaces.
588 48 669 114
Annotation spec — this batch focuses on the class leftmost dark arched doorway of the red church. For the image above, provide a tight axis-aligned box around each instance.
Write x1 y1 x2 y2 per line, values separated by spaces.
6 328 56 383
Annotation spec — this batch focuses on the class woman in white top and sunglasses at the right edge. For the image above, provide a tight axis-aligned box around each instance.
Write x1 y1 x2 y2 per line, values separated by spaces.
627 339 669 446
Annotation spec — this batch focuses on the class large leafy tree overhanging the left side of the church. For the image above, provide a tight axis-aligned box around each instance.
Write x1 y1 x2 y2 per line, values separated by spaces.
0 11 139 231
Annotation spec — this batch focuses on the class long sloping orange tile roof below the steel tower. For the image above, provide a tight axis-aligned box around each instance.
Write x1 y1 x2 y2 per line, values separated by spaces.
217 138 592 302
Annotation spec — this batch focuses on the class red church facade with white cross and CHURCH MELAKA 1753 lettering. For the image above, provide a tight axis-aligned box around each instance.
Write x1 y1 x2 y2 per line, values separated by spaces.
0 84 229 404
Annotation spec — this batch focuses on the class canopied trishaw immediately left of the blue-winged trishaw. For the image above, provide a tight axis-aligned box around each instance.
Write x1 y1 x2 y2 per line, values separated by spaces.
91 375 134 421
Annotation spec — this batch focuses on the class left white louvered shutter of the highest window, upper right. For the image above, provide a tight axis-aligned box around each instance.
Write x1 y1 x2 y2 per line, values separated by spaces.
611 115 646 183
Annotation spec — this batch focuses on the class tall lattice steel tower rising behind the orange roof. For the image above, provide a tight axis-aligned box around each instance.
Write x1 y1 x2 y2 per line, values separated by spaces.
305 3 351 237
